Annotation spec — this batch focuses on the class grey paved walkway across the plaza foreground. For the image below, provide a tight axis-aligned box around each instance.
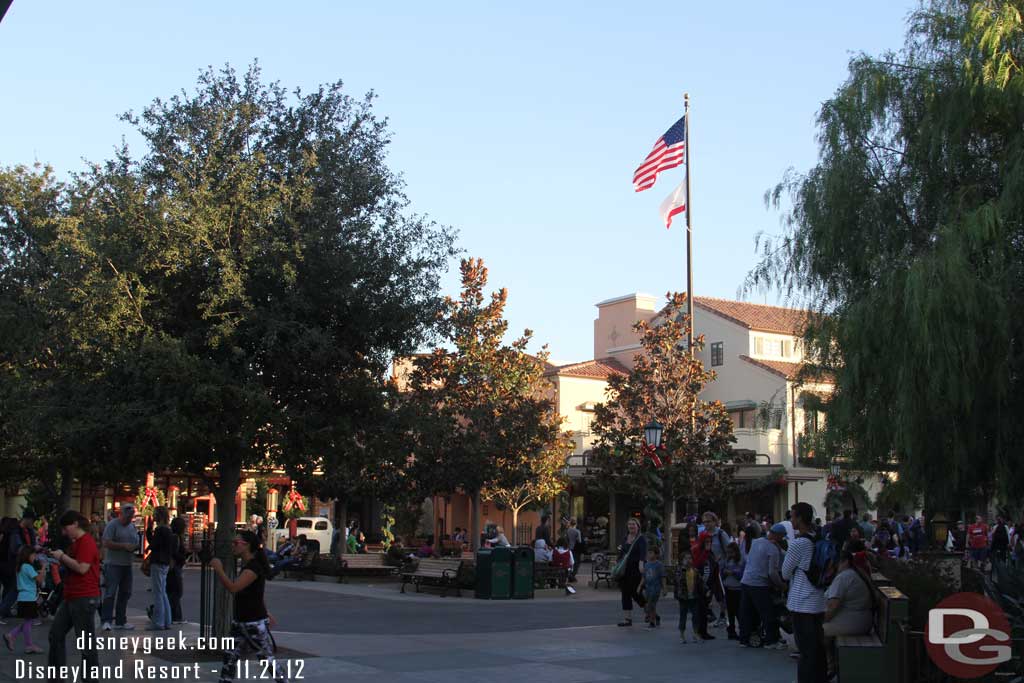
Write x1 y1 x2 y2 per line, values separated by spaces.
0 582 796 683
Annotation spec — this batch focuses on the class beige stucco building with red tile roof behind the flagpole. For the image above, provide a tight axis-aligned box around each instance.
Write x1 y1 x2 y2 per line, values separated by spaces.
548 294 881 539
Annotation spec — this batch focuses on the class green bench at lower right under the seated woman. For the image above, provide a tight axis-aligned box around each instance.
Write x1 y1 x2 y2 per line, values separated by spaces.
836 574 909 683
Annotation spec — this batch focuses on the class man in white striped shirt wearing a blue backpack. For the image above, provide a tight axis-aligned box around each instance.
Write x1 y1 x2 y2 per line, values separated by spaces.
782 503 836 683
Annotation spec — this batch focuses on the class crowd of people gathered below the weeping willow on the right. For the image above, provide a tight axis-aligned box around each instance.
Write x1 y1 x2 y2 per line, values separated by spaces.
612 503 937 683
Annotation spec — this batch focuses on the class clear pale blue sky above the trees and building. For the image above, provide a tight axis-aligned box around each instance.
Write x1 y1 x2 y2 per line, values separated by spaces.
0 0 916 361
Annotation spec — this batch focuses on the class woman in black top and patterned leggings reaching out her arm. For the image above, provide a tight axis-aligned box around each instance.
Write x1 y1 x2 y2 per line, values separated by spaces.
210 529 288 683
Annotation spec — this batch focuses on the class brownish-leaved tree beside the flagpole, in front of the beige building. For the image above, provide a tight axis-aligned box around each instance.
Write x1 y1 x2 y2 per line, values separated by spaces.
591 294 736 557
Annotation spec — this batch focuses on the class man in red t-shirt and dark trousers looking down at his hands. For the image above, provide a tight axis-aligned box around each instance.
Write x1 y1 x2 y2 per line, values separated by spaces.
49 510 99 680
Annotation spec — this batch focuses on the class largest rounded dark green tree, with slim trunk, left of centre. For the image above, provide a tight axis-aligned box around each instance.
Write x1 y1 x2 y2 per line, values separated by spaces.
84 66 453 628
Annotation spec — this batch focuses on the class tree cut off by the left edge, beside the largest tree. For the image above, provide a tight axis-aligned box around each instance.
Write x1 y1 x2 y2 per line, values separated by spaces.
0 165 147 512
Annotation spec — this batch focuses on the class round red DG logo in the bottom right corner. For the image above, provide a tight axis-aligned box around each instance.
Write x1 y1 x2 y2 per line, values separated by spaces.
925 593 1011 679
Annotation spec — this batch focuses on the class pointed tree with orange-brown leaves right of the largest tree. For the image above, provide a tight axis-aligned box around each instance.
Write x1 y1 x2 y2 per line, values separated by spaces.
407 259 569 546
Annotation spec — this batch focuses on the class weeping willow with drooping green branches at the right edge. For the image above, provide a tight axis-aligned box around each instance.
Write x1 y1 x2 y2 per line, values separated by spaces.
746 0 1024 507
